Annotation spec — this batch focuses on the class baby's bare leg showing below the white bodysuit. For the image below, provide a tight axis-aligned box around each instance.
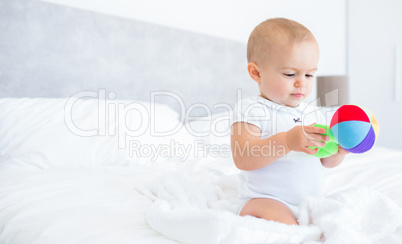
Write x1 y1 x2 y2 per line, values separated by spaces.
240 198 298 225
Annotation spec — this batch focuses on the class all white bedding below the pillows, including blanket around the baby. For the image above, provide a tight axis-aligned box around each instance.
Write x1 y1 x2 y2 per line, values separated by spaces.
0 150 402 244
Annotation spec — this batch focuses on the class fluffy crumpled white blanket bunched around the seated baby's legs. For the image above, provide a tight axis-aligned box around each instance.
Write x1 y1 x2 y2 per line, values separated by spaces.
146 170 402 243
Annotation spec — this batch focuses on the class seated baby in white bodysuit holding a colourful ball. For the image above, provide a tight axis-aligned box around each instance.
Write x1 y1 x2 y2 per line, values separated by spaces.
231 18 347 224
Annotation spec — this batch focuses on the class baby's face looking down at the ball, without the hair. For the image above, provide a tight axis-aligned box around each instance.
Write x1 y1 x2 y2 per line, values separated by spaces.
258 41 319 107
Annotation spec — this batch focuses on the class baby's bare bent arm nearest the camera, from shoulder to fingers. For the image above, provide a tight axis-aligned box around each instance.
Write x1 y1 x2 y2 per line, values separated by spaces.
231 122 328 170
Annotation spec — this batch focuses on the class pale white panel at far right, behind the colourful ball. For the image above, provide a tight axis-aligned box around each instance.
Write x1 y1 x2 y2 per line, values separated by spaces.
349 0 402 149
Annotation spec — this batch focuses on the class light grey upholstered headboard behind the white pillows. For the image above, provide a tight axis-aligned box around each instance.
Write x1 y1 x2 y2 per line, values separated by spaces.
0 0 254 113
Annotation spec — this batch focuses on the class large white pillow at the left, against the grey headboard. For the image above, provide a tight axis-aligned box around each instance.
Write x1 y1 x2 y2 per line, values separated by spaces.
0 97 194 168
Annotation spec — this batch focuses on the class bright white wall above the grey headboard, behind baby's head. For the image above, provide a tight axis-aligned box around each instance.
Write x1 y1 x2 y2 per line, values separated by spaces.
41 0 346 75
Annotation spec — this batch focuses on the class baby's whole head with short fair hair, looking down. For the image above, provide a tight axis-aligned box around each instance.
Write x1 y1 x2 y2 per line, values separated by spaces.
247 18 319 107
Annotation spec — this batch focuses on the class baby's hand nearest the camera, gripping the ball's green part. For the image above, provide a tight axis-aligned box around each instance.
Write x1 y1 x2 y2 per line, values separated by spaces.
286 125 329 154
